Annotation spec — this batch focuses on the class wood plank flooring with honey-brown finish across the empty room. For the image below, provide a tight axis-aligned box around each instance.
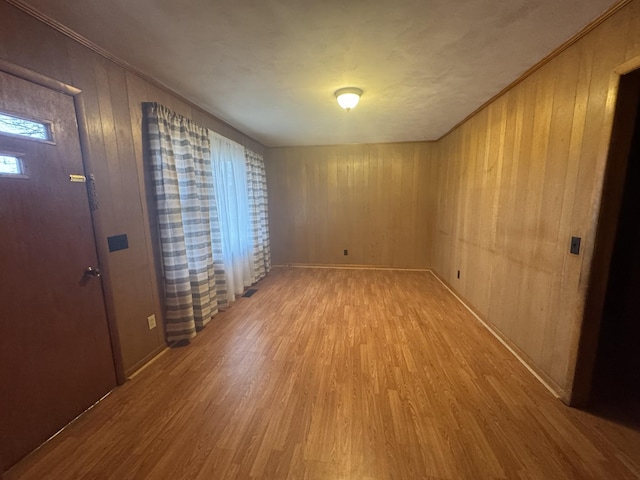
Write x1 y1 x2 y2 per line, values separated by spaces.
5 268 640 480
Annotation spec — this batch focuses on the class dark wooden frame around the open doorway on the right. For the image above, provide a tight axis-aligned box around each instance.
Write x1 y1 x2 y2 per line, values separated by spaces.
568 56 640 407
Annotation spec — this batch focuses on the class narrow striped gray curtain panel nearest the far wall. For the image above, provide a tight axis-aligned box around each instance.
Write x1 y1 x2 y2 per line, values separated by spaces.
245 149 271 281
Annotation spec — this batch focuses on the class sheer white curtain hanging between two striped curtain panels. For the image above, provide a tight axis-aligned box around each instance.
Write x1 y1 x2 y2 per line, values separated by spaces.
209 131 256 302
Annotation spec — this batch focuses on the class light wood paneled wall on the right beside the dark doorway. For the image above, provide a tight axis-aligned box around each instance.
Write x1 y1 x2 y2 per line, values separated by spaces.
432 0 640 400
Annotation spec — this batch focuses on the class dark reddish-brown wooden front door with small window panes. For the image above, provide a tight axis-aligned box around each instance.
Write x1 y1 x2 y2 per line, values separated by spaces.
0 72 116 472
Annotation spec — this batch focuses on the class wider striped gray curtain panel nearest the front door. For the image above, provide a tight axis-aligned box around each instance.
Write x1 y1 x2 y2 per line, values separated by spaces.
145 103 227 342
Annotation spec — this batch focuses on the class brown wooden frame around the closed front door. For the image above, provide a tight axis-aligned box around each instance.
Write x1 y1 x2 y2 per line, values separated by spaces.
0 58 127 384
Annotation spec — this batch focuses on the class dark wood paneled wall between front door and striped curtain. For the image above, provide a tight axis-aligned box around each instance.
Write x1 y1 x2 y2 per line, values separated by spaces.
0 0 263 373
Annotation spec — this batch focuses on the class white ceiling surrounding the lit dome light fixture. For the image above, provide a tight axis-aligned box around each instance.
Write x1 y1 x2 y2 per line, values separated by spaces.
23 0 619 146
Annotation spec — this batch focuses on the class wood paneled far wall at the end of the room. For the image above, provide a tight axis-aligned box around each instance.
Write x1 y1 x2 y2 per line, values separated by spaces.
265 142 436 268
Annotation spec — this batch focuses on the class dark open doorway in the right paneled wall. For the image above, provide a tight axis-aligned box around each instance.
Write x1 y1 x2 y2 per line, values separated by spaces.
589 65 640 429
